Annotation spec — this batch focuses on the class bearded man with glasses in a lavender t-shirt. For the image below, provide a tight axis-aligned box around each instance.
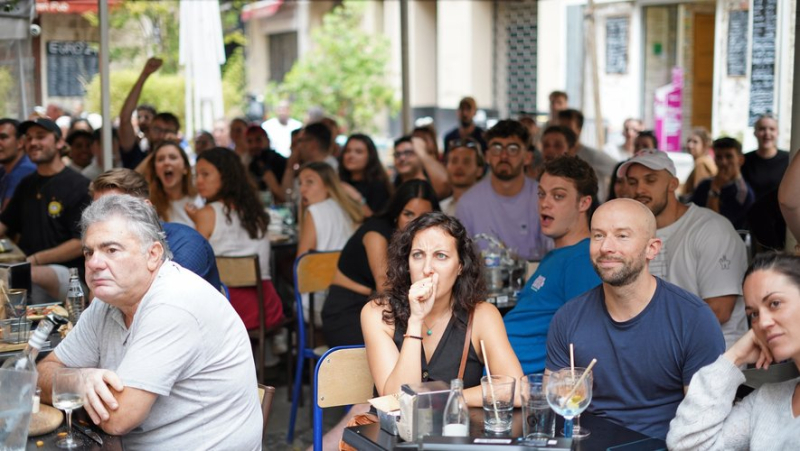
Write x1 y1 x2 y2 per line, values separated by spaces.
456 119 552 260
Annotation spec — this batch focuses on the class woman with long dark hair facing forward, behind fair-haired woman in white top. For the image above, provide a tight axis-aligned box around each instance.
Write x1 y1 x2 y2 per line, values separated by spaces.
339 133 392 216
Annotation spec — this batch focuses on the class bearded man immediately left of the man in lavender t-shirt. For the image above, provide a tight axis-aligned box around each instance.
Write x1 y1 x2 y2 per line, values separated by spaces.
439 138 486 216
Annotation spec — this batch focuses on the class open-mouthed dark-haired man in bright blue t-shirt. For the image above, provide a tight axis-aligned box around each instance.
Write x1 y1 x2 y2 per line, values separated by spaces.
503 156 600 374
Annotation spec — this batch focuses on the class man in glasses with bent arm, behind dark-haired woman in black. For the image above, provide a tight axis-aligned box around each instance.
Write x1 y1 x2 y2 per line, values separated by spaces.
394 135 452 199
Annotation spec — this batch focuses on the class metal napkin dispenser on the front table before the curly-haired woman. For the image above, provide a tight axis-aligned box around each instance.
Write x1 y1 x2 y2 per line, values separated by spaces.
399 381 450 441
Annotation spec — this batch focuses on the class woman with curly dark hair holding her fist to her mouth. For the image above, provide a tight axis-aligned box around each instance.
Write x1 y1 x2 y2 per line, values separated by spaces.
361 212 522 406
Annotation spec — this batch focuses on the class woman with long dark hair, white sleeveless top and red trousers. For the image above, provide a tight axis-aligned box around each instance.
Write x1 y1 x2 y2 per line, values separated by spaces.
187 147 283 329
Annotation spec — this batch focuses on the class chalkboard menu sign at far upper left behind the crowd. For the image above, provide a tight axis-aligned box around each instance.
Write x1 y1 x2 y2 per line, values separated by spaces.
47 41 100 97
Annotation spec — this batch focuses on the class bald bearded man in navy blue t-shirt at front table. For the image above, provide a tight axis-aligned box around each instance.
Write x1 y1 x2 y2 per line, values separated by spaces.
547 199 725 439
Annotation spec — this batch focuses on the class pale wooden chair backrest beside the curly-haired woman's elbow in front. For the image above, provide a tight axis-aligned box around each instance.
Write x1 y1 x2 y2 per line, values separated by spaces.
314 346 375 409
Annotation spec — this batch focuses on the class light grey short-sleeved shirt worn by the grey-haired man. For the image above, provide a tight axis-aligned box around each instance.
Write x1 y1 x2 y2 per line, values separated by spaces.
54 261 262 450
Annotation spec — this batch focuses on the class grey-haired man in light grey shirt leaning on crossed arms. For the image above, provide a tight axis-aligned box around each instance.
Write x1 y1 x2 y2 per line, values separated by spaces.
38 195 262 450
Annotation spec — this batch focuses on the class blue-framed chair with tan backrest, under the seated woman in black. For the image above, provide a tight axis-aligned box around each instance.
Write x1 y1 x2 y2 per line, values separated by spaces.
286 251 340 443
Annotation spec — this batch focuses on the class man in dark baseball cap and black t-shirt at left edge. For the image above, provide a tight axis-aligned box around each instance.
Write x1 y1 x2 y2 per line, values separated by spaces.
0 118 91 302
